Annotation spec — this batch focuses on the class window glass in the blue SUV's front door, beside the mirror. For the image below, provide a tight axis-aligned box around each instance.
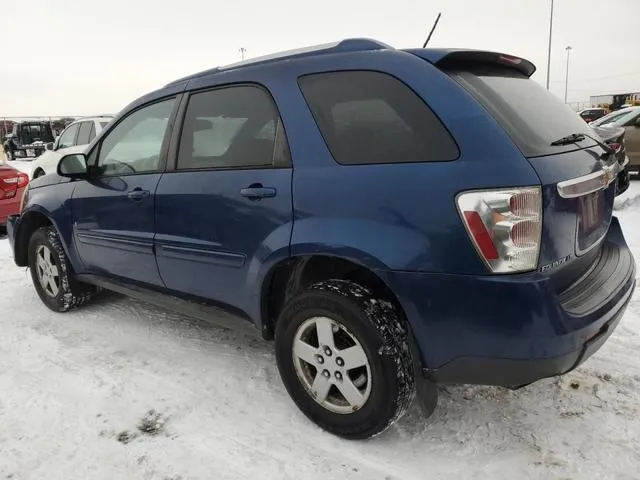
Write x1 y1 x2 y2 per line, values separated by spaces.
98 98 175 176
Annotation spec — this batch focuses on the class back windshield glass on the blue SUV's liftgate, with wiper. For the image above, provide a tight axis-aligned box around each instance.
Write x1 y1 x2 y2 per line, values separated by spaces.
448 66 596 157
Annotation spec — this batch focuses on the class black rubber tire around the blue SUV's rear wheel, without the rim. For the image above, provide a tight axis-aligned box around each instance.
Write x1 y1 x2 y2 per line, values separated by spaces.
275 280 416 439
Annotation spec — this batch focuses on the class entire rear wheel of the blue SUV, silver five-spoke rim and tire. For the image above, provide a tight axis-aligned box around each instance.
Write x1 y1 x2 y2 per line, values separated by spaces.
276 280 415 439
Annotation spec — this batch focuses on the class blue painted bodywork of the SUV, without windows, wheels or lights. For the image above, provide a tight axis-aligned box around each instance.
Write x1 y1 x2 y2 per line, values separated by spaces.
8 42 635 380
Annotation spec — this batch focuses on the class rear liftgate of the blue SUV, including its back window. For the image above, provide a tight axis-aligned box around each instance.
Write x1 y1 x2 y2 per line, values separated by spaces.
441 54 617 290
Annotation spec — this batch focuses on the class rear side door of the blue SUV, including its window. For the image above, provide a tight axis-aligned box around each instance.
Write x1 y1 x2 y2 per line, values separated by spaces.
155 85 293 308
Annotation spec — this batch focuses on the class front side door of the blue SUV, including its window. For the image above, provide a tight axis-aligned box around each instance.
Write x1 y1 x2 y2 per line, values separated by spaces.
72 98 175 286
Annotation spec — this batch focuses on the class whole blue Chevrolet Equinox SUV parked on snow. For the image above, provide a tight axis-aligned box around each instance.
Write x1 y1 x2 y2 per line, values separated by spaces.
8 39 635 438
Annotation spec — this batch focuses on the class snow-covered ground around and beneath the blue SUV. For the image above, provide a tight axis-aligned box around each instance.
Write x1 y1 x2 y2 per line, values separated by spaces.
0 164 640 480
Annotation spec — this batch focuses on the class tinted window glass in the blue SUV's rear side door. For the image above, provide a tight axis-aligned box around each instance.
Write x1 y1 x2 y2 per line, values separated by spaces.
178 85 279 170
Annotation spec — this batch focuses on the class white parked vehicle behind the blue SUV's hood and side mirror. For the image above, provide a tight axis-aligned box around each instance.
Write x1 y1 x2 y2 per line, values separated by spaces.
31 116 113 178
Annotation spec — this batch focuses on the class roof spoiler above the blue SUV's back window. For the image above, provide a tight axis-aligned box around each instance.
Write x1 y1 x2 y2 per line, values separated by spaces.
407 48 536 77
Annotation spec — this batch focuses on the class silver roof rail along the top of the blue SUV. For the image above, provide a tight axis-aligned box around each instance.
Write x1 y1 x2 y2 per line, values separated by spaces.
165 38 393 87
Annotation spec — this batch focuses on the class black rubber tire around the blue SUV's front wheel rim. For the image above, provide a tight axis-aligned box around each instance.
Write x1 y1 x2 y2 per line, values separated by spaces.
29 226 96 312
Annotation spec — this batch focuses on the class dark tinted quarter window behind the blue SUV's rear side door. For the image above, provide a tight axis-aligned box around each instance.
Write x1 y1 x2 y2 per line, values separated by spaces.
298 71 459 165
